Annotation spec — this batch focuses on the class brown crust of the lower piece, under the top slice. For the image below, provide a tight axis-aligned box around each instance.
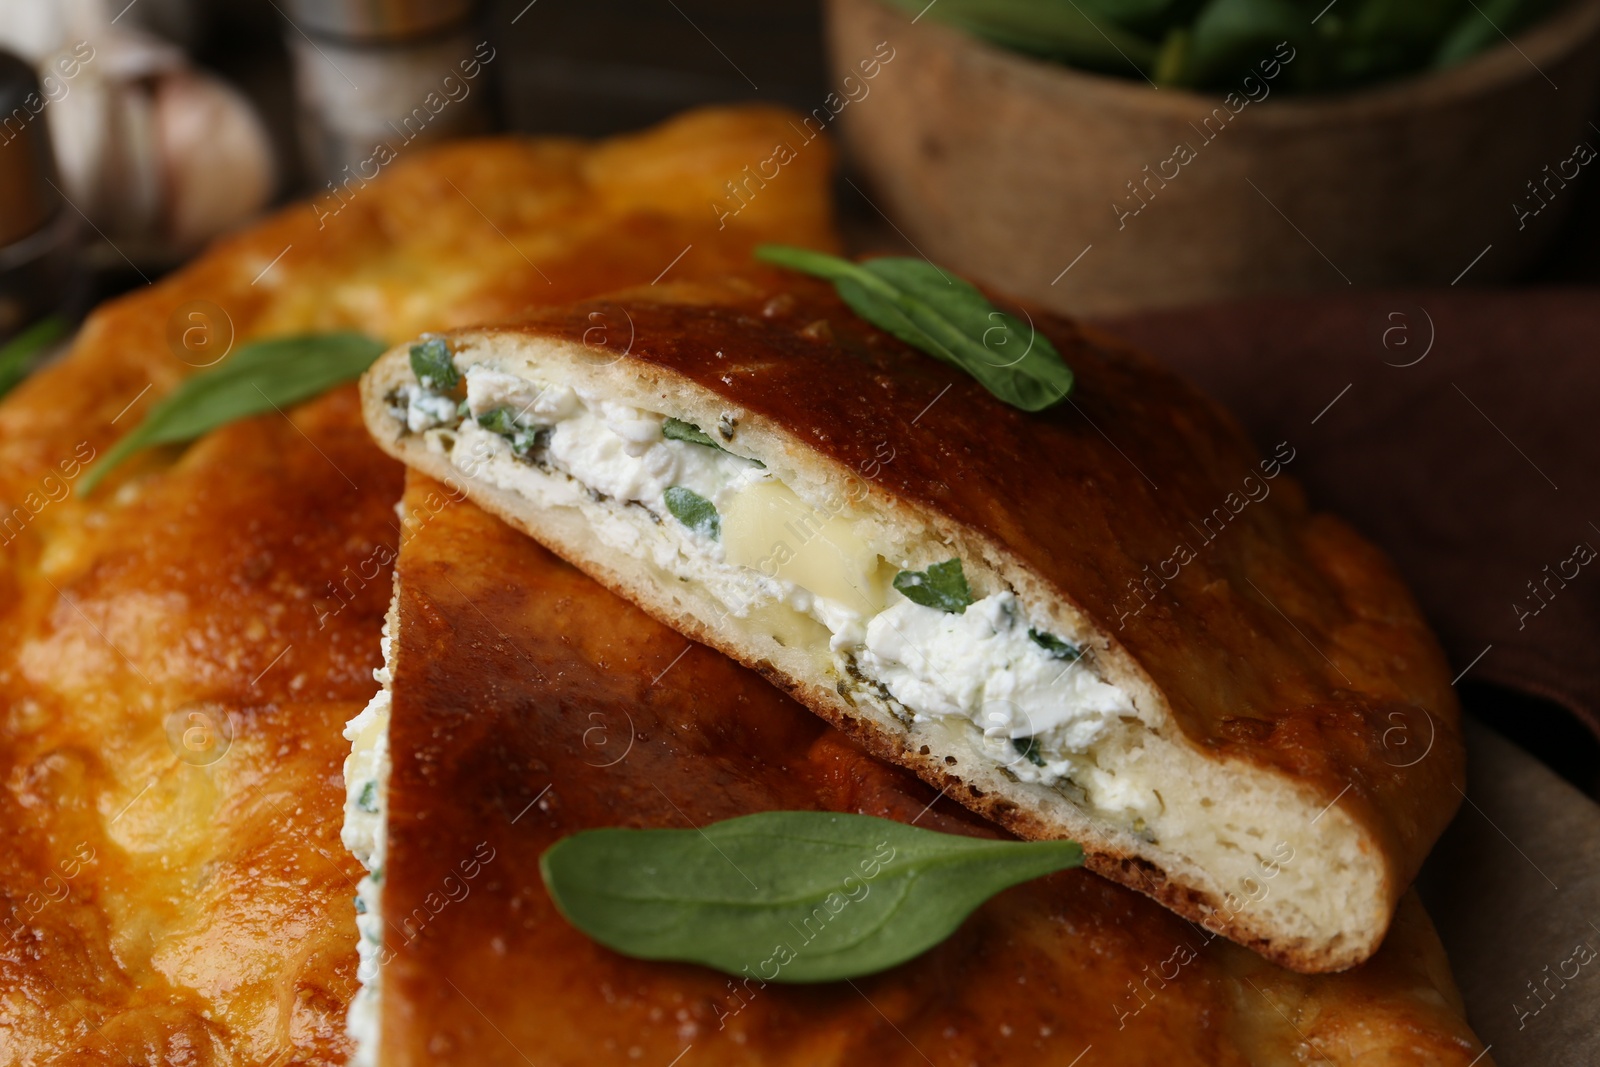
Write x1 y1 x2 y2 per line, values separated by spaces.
371 474 1488 1067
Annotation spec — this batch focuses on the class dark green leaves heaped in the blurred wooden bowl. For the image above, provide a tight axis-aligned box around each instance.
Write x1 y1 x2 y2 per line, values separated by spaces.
890 0 1562 93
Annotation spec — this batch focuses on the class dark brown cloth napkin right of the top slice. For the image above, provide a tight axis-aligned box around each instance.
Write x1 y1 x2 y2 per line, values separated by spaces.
1099 288 1600 748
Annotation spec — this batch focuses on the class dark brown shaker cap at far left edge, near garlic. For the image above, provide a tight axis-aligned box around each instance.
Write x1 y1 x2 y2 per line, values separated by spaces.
0 51 61 246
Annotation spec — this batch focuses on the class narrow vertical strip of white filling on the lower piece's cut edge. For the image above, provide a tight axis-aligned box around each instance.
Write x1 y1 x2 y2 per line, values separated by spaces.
339 624 394 1067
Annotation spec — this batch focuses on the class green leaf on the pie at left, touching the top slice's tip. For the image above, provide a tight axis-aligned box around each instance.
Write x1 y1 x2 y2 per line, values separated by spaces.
77 333 384 493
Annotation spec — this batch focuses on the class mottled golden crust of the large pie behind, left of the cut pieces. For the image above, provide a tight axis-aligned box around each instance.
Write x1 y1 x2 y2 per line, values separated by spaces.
0 109 832 1064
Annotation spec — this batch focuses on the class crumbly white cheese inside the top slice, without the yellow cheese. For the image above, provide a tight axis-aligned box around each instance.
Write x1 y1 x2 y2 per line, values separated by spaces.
430 365 1160 819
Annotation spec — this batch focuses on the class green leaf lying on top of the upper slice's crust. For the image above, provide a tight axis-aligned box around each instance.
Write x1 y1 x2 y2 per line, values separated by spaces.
755 245 1072 411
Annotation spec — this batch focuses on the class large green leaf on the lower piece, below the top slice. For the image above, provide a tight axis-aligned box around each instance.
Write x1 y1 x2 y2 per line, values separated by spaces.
539 811 1083 982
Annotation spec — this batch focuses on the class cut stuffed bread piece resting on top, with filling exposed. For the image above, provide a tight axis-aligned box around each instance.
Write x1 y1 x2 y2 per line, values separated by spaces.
362 272 1464 971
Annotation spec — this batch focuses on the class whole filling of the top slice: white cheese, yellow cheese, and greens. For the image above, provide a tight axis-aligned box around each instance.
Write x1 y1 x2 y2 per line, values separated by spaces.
389 363 1160 830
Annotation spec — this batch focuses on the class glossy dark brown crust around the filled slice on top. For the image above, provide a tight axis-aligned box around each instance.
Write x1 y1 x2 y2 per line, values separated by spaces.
366 272 1464 971
